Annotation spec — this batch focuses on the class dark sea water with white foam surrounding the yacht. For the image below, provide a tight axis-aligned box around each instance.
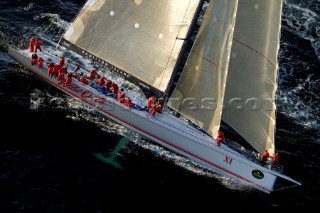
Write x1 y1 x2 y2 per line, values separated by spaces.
0 0 320 213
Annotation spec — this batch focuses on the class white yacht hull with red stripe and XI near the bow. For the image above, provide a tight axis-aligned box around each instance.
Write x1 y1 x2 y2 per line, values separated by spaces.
9 46 300 193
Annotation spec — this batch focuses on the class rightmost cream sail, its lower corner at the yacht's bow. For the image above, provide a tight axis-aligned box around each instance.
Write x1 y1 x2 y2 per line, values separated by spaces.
222 0 282 155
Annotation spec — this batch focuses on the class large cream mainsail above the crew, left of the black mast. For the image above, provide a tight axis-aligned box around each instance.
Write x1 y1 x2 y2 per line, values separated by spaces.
60 0 200 96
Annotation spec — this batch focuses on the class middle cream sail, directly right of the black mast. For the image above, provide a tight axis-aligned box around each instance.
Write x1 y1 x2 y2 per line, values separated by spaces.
168 0 238 137
